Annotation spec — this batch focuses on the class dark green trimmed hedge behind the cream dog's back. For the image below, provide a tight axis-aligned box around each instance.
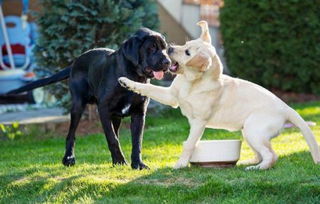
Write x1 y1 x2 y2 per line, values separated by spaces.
221 0 320 94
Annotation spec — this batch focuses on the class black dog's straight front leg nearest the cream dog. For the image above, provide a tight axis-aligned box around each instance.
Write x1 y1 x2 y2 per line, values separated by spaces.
130 113 149 170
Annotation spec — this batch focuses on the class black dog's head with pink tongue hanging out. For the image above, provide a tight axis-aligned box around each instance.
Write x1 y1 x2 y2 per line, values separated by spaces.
120 28 171 79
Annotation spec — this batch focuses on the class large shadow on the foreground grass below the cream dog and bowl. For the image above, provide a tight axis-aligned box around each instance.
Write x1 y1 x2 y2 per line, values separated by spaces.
99 152 320 203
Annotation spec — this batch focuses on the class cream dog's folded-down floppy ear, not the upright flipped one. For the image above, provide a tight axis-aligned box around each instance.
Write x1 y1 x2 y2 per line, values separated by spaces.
186 51 212 72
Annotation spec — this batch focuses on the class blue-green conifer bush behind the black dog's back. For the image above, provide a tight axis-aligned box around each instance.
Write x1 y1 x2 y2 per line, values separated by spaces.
35 0 158 108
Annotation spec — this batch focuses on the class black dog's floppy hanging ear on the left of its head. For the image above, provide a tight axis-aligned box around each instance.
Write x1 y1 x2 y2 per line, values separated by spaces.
122 37 141 66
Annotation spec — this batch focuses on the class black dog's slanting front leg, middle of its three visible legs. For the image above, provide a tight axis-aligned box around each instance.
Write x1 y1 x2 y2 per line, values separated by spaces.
98 105 127 165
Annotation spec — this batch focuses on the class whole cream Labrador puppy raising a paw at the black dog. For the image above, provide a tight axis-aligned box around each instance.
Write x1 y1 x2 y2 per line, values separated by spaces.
119 21 320 169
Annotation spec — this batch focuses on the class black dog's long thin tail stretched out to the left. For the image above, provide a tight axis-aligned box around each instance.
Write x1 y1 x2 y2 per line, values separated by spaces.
7 67 71 95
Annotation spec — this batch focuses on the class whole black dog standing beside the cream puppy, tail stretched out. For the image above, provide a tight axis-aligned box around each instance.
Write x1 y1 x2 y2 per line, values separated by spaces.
8 28 170 169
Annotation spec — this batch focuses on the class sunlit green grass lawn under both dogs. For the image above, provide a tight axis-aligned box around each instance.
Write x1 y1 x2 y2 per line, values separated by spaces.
0 102 320 204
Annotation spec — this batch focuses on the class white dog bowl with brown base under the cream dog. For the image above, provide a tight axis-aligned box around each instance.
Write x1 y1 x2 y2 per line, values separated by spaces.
190 140 241 168
